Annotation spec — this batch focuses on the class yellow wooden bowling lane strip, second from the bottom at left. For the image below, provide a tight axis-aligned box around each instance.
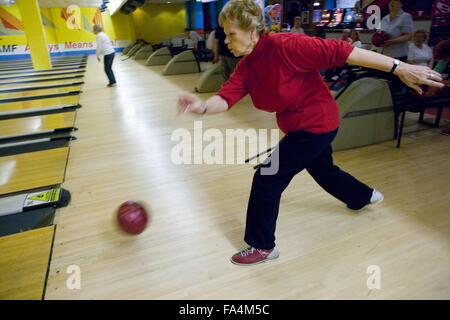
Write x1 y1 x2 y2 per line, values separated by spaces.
0 147 69 195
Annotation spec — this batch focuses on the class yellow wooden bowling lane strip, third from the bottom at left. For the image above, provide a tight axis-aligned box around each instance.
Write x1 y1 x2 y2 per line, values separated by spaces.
0 111 75 138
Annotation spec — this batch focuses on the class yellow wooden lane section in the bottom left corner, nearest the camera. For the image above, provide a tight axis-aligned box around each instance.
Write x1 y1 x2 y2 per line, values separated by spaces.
0 225 55 300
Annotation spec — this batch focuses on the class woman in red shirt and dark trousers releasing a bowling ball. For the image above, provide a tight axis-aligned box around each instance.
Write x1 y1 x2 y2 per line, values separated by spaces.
178 0 442 265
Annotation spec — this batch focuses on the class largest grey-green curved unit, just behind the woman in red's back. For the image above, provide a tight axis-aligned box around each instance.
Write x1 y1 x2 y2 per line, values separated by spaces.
332 77 395 150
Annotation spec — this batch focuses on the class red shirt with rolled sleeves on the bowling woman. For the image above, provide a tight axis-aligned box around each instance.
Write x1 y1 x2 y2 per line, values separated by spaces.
217 33 354 134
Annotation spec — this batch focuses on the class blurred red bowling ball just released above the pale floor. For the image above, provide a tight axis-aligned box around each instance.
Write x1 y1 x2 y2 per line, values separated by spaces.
117 201 148 234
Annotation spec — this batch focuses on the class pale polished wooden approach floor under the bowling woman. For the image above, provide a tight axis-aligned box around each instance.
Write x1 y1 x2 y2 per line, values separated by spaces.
45 55 450 299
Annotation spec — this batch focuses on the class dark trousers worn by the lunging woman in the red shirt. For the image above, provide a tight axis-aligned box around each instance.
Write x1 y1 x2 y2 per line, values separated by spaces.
244 129 373 250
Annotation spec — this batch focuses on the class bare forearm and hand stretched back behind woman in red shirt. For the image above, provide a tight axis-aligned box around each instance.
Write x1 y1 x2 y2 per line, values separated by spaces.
346 48 444 94
